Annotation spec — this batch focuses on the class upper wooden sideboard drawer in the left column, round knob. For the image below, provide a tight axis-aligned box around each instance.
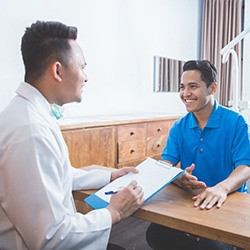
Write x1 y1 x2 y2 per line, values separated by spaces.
117 123 147 142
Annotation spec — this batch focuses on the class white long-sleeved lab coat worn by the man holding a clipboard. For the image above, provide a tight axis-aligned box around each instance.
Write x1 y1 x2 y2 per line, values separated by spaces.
0 83 112 250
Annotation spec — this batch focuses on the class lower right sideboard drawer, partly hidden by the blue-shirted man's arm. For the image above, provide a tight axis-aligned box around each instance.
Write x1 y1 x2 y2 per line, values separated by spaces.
147 135 168 157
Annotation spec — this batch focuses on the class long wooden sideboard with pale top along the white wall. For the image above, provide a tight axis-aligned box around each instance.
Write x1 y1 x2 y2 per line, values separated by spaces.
60 115 180 168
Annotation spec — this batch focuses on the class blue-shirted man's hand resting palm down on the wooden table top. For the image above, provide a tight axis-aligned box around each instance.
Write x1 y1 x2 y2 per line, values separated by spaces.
193 184 227 209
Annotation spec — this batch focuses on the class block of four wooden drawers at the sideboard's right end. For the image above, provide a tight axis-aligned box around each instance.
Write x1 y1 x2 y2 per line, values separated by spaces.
117 119 175 167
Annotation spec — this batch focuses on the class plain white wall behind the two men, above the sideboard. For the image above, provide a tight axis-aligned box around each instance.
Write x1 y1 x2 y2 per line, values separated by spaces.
0 0 200 116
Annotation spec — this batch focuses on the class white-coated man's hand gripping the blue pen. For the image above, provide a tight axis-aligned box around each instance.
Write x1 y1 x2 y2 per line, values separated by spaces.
107 181 144 224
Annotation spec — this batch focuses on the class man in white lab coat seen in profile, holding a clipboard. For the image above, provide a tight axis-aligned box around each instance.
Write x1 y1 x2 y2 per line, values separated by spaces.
0 21 143 250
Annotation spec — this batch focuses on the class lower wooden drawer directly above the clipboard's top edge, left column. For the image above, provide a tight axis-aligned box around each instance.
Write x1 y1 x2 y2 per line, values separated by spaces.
117 139 146 163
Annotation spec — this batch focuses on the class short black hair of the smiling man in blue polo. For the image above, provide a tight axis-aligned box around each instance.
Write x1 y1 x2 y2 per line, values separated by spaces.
183 60 217 87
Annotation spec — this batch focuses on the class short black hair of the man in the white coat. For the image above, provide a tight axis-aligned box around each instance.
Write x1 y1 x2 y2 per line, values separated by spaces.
21 21 77 83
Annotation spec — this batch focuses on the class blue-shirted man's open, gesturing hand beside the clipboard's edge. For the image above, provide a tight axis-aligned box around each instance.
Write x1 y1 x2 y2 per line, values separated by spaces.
174 164 207 190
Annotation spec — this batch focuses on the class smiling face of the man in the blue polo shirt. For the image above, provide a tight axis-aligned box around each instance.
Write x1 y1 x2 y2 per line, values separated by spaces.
180 70 217 113
